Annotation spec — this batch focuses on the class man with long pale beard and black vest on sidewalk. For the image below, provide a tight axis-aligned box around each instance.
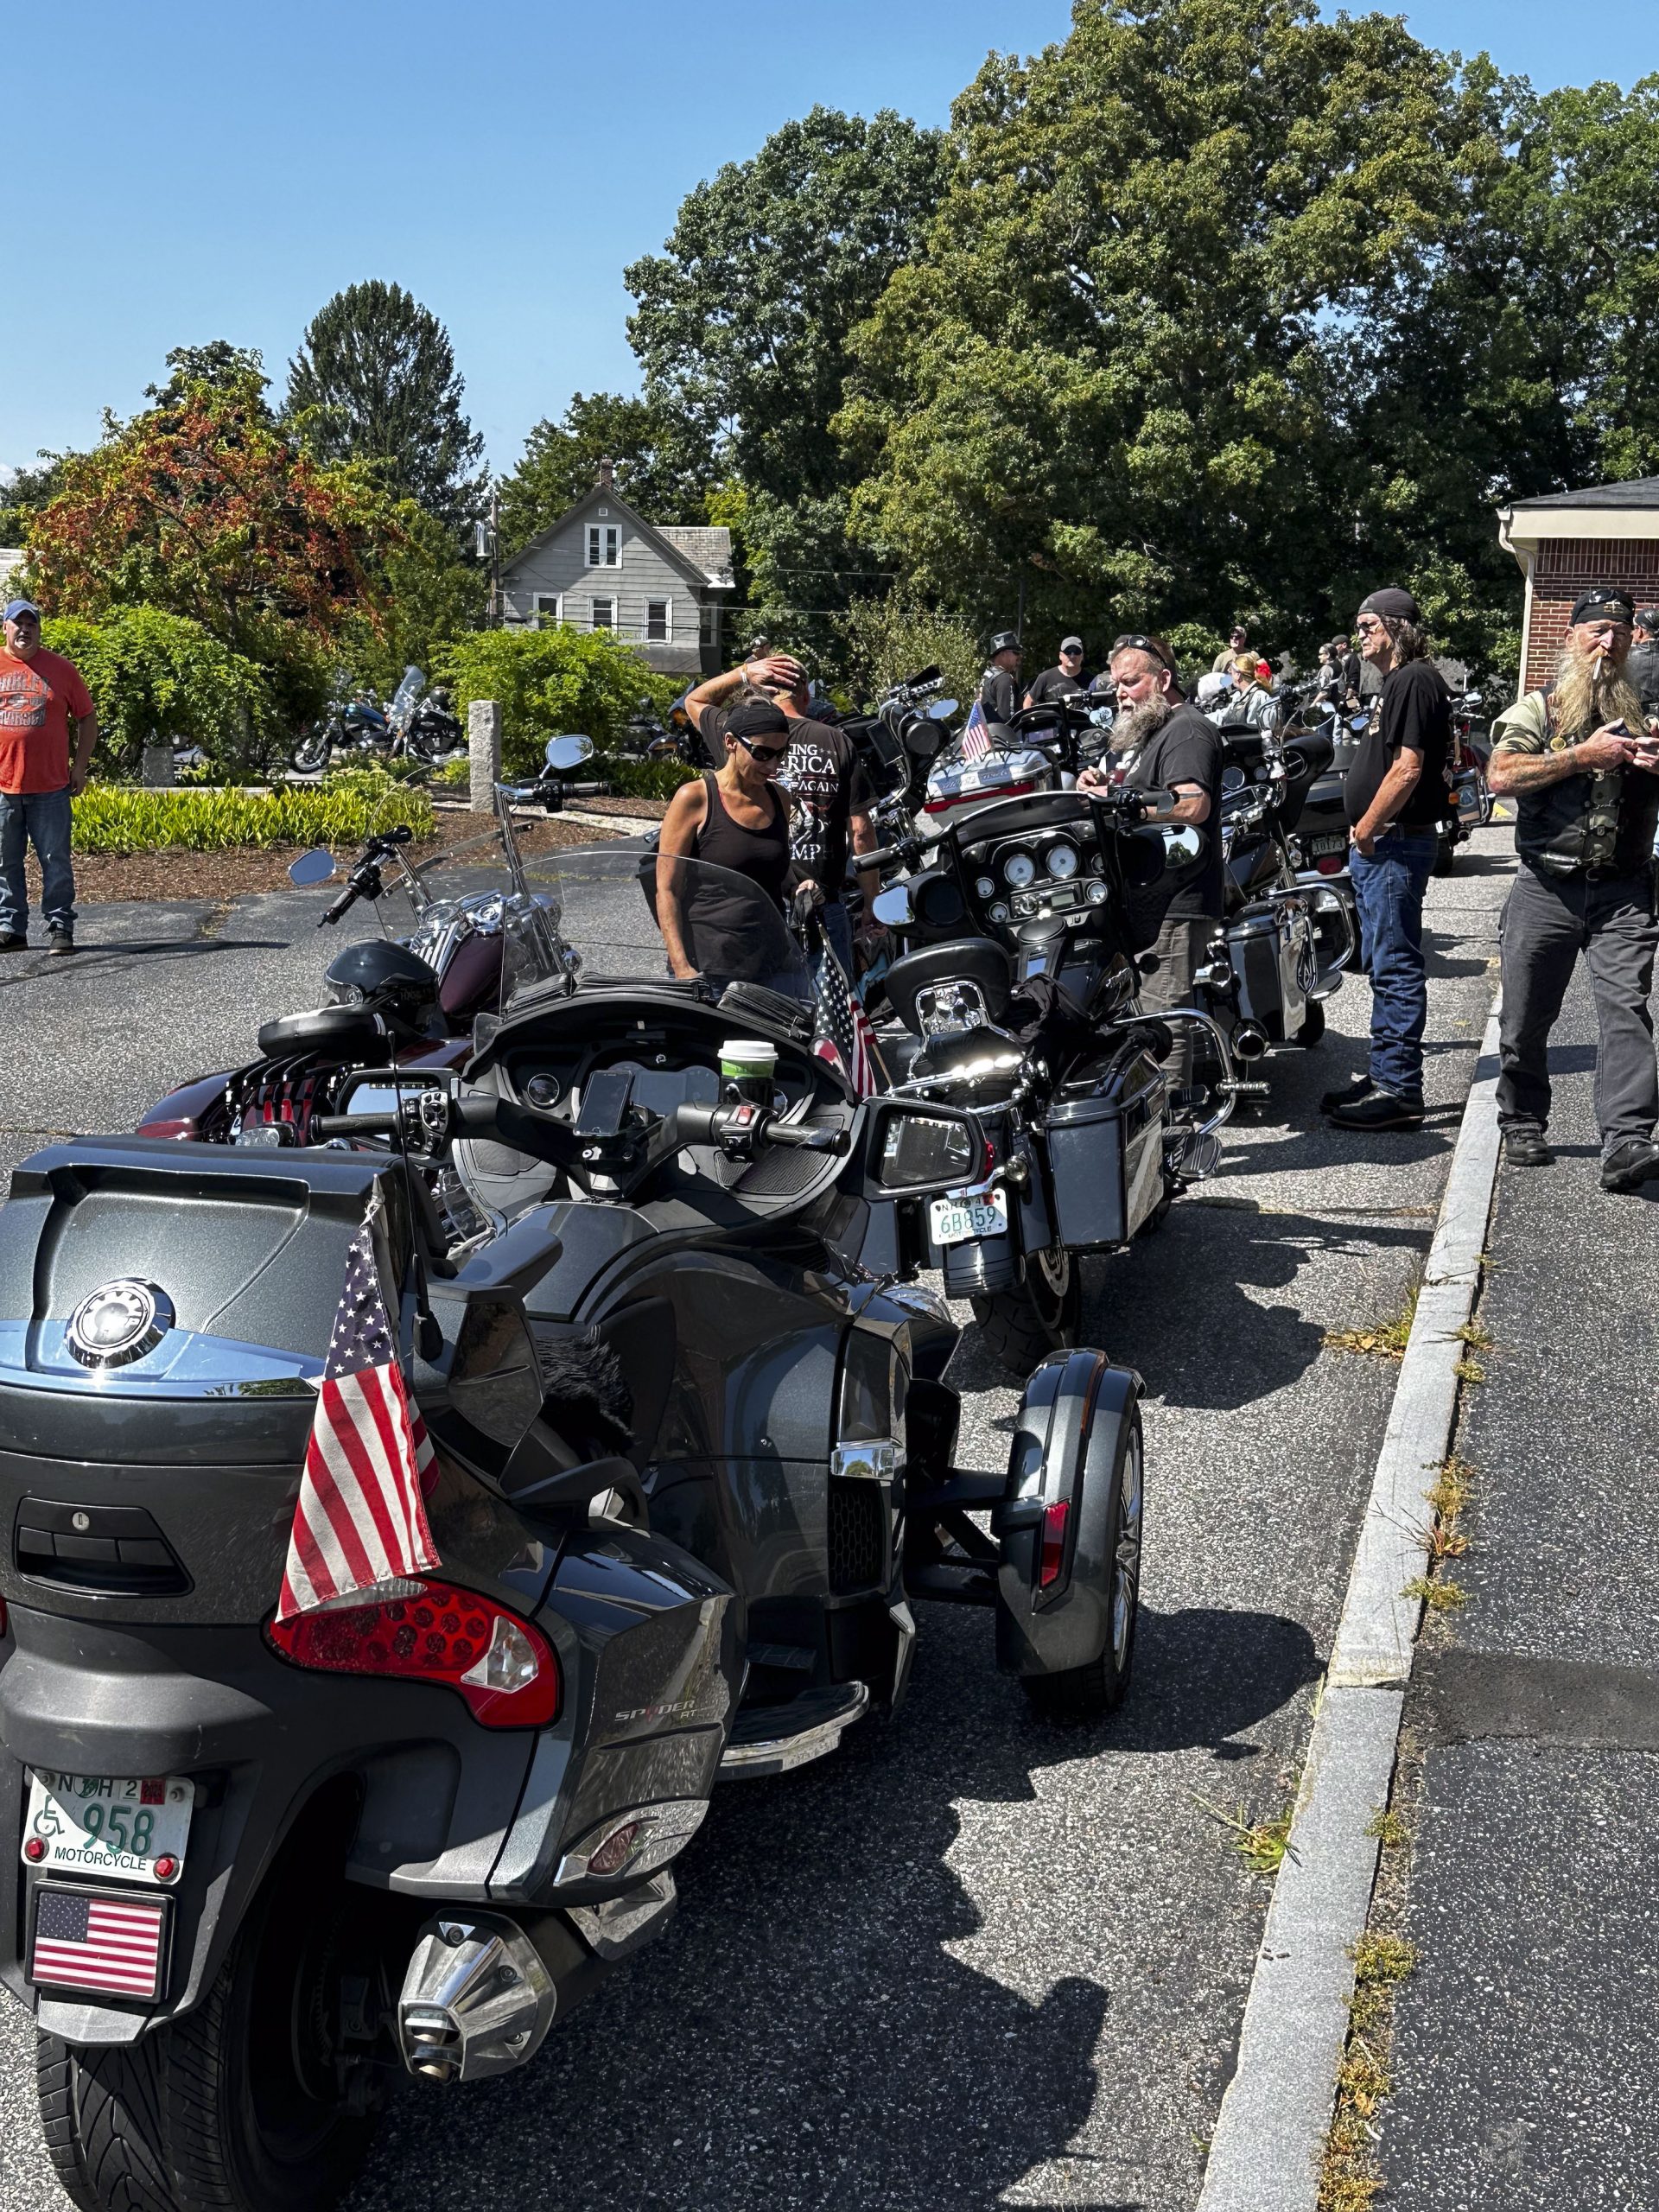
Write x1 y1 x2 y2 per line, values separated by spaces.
1486 591 1659 1190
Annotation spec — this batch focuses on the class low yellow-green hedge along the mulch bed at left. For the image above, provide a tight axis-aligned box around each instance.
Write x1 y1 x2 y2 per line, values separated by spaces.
75 783 438 854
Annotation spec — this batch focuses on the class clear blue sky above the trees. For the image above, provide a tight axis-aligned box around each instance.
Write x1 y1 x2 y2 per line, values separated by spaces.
0 0 1659 484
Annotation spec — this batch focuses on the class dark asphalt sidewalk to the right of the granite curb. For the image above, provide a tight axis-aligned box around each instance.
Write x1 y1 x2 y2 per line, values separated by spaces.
1380 971 1659 2212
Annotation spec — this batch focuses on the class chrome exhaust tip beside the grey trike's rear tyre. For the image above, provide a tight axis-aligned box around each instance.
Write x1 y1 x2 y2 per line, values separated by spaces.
398 1911 557 2082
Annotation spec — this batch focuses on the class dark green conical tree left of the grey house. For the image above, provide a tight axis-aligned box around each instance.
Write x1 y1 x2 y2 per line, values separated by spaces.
285 279 485 529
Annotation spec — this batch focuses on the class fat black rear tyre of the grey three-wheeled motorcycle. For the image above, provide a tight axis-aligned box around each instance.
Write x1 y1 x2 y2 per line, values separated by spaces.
38 1853 378 2212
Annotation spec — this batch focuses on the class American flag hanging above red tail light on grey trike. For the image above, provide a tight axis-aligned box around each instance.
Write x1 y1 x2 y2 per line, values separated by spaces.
276 1208 438 1621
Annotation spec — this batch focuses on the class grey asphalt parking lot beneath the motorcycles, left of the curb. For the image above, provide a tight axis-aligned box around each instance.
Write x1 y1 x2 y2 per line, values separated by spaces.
0 830 1509 2212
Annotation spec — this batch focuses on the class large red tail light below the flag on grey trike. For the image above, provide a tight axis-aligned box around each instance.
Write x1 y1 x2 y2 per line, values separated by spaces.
265 1577 564 1727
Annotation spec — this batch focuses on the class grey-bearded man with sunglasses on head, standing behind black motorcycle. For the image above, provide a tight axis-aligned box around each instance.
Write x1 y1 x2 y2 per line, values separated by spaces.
1077 635 1224 1090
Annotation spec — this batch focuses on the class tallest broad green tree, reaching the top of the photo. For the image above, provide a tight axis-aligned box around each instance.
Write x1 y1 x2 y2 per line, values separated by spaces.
838 0 1496 635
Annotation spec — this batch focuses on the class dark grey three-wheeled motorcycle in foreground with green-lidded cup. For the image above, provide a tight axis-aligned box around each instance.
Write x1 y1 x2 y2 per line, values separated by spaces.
0 854 1141 2212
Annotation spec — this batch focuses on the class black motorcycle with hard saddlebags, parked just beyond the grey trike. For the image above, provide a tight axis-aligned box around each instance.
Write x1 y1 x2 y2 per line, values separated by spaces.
858 790 1255 1376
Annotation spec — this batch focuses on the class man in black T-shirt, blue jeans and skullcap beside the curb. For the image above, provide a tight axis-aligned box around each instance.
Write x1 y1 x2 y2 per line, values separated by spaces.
1320 588 1451 1130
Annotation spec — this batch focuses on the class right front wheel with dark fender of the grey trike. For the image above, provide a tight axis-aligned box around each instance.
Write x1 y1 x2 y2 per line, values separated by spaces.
991 1347 1141 1675
